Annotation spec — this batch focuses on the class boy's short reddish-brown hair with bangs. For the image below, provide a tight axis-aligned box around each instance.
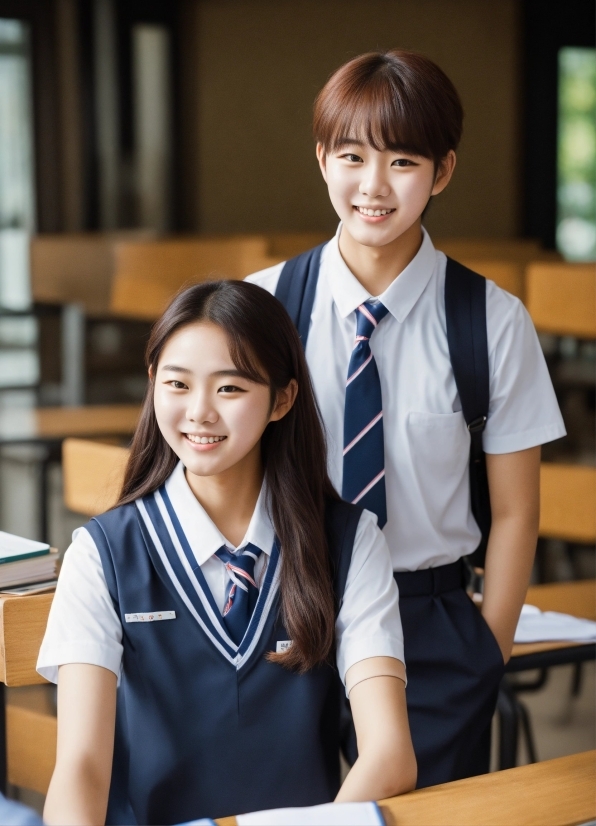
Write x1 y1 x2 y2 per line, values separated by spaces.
313 49 464 165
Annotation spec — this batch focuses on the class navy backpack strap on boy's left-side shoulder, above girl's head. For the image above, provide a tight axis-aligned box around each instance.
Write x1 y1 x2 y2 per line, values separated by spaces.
275 241 328 350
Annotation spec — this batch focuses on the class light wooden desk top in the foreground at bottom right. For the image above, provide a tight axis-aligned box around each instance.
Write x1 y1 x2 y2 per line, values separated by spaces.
217 751 596 826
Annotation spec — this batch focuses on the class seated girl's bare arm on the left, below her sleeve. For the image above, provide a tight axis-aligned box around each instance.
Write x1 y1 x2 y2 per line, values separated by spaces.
43 663 116 826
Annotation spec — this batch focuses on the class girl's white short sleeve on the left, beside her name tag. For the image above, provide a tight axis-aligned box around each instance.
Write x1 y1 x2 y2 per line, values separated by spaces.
37 528 122 683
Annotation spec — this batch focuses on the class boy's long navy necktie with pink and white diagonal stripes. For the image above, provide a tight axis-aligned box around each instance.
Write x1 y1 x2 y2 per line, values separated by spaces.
342 301 388 528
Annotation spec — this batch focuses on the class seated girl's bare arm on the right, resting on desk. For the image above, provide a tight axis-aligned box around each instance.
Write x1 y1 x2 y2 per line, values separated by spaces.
336 657 416 803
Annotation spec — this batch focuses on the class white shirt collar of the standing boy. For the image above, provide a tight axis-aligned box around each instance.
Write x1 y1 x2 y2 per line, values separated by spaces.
324 223 437 322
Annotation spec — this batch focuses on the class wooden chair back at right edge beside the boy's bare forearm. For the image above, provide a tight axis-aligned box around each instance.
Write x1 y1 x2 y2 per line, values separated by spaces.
539 462 596 543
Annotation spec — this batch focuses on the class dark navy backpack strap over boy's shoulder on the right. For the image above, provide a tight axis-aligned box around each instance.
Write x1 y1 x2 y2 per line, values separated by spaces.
445 258 491 568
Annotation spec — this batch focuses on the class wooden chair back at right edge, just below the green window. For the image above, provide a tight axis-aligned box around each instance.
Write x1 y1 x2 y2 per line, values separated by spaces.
526 261 596 339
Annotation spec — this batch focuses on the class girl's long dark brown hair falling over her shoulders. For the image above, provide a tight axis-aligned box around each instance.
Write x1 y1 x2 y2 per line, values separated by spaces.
118 281 339 673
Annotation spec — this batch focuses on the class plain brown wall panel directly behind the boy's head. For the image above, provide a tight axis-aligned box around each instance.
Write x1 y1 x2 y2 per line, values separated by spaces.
191 0 520 238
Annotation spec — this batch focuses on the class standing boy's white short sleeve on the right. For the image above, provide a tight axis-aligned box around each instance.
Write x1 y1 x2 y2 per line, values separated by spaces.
483 281 565 453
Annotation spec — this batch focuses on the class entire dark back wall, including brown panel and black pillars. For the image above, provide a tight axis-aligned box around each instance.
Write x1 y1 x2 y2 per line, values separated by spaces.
0 0 593 246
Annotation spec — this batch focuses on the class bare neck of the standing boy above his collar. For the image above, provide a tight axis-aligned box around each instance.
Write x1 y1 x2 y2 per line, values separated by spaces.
339 220 422 296
